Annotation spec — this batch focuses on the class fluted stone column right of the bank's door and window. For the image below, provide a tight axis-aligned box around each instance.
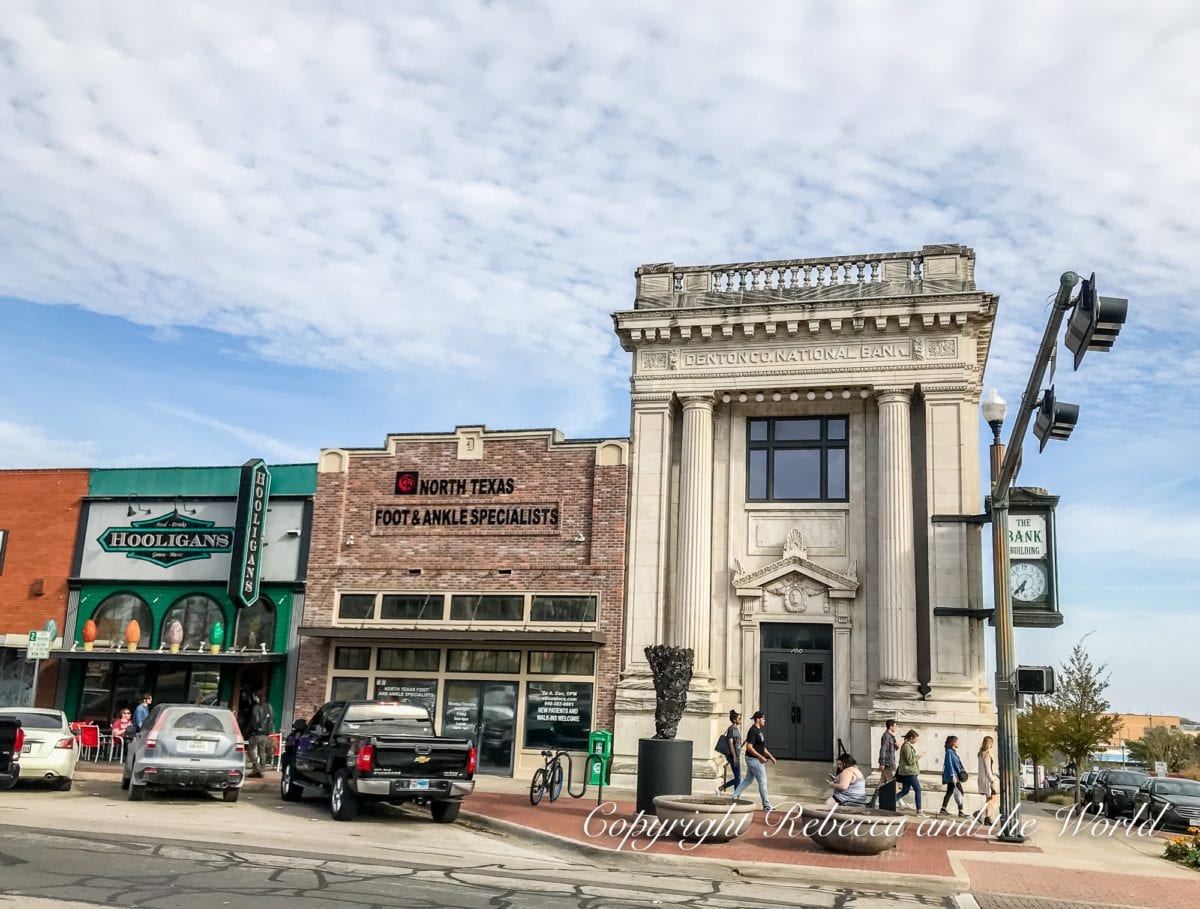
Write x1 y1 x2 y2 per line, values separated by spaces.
876 389 918 698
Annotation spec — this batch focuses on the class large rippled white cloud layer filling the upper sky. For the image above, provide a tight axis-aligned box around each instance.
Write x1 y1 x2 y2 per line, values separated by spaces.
0 2 1200 443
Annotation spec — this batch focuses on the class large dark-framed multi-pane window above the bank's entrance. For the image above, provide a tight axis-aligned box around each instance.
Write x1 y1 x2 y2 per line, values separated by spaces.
746 416 850 501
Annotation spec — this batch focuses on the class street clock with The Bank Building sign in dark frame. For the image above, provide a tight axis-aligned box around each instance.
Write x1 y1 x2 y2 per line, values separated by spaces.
1008 487 1062 628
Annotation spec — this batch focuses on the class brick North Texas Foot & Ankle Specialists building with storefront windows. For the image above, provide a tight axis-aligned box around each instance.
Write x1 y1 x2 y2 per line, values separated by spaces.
295 427 629 775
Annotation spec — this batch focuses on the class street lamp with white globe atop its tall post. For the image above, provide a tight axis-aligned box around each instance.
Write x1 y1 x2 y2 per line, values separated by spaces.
980 389 1025 843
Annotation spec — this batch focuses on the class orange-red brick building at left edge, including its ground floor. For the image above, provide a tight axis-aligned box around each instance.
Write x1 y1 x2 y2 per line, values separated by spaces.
0 470 88 706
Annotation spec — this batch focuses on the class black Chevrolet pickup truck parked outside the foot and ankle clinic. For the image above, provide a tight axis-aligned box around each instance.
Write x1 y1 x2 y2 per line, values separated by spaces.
280 700 476 824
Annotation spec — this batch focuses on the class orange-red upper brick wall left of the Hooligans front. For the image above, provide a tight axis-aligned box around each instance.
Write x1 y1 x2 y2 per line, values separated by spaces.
0 470 89 634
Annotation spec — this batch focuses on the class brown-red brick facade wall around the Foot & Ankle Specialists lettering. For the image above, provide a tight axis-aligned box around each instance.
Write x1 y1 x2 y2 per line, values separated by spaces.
296 433 629 729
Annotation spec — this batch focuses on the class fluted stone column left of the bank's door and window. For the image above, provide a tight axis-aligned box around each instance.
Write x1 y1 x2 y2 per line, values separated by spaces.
673 395 713 675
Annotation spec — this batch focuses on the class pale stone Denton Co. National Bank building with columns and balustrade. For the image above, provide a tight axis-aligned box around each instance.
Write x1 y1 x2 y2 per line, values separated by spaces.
613 246 997 782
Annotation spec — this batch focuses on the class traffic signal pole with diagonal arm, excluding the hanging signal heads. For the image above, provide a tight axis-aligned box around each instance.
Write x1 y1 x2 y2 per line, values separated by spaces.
989 271 1079 843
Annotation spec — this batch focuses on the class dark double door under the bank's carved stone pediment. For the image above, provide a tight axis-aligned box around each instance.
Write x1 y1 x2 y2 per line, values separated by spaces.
760 636 834 760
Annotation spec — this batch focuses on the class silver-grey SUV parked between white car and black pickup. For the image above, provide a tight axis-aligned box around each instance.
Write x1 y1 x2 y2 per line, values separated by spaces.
121 704 246 802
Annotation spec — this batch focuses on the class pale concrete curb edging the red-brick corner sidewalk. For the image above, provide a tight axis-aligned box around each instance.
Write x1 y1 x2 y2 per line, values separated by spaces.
460 802 971 905
